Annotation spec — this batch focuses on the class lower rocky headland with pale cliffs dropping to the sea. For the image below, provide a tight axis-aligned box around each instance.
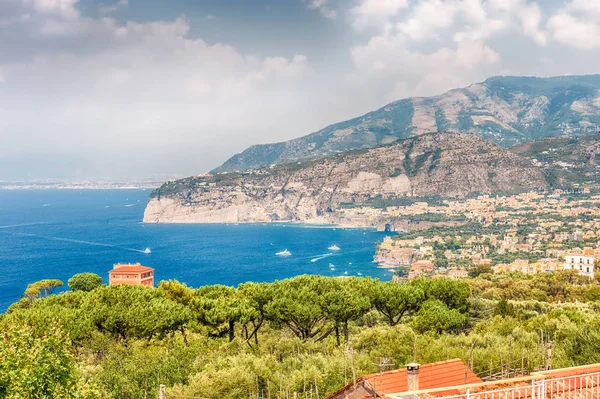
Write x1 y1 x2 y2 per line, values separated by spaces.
144 133 546 223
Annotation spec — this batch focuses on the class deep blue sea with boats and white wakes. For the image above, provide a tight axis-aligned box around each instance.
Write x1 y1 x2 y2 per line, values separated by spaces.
0 190 392 312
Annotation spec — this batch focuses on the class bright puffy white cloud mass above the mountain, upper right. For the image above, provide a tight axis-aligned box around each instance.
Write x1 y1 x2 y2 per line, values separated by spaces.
342 0 572 104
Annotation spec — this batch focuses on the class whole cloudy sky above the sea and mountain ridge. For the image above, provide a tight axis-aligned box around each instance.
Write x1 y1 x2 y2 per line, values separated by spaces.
0 0 600 180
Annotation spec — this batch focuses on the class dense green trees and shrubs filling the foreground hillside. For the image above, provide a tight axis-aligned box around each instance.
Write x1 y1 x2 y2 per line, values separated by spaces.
0 271 600 399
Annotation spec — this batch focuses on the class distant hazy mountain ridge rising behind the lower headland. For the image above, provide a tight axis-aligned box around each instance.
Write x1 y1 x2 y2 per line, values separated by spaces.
213 75 600 173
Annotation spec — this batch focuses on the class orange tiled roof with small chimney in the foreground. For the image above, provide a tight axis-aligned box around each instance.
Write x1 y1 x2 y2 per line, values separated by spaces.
327 359 482 399
